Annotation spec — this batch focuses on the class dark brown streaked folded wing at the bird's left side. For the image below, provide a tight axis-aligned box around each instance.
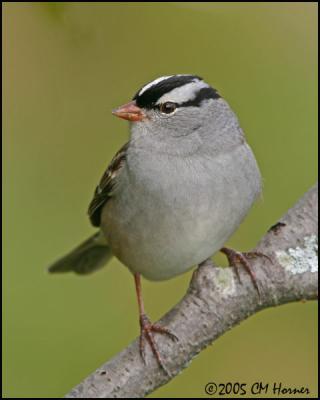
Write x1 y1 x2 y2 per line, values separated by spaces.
88 143 128 226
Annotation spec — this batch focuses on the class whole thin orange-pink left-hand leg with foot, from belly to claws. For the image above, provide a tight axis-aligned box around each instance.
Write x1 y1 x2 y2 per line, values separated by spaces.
134 273 178 375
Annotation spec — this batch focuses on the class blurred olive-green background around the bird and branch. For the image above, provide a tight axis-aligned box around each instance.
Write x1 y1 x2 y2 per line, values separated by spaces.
3 2 317 397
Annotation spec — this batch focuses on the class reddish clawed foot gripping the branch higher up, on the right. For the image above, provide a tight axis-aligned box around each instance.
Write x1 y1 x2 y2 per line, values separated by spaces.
220 247 272 297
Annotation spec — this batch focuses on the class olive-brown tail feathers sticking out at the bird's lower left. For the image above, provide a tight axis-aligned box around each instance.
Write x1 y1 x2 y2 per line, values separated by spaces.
48 231 112 274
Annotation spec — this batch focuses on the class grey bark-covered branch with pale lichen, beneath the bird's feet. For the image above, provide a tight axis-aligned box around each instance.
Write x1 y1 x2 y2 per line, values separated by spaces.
66 185 318 398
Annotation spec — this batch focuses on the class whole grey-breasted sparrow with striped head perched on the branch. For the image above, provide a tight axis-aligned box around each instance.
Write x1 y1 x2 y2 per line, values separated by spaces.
49 74 264 369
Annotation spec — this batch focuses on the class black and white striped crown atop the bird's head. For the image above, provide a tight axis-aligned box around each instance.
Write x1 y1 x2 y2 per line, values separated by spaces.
133 75 220 108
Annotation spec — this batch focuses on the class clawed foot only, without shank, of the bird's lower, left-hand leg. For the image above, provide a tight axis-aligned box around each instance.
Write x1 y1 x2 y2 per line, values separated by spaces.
140 314 178 376
